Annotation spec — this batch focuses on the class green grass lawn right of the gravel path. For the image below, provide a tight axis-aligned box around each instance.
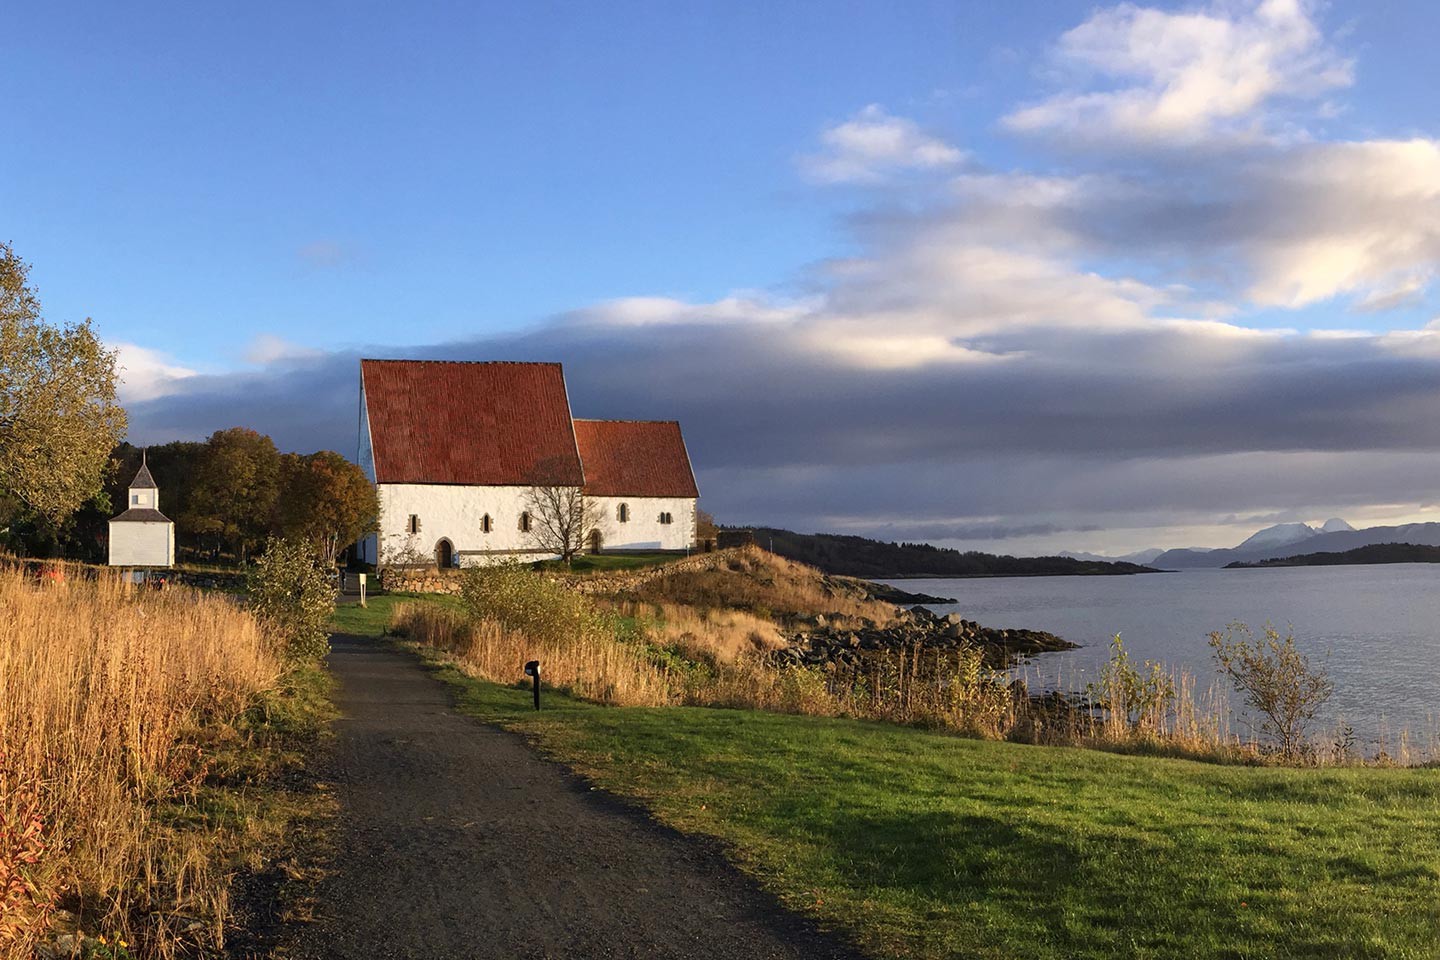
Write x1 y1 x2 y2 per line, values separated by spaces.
420 653 1440 960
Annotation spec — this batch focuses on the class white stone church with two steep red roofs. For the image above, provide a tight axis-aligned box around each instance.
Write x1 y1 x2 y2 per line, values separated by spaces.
357 360 700 567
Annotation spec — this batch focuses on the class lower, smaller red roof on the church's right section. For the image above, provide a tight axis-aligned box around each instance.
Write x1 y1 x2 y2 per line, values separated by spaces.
575 420 700 497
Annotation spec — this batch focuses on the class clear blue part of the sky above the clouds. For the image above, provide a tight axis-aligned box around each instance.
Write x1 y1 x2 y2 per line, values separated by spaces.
0 3 1035 359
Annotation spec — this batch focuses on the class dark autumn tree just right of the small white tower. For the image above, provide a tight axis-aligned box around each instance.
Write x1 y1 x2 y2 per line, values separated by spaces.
184 426 279 563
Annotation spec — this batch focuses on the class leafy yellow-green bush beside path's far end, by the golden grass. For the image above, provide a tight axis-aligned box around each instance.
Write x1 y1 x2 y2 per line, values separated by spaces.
249 537 337 659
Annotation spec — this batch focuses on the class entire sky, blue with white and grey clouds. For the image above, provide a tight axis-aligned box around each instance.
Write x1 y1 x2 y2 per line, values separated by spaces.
8 0 1440 553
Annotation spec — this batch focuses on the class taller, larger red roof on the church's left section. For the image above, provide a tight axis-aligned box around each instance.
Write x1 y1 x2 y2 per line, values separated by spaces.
360 360 585 486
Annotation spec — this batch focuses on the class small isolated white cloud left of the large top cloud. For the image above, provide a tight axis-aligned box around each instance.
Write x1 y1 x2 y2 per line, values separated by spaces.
801 104 965 183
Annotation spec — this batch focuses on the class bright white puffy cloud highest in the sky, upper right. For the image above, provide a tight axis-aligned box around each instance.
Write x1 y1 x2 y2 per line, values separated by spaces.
1005 0 1354 144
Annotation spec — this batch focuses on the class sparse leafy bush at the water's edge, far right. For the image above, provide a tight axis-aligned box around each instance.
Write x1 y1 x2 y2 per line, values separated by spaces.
1210 623 1335 760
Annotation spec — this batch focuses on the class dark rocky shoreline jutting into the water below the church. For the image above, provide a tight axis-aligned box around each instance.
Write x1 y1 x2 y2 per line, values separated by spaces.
772 606 1077 669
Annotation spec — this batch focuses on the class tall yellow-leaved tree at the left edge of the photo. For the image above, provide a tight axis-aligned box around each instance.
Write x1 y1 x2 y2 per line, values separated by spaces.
0 243 125 525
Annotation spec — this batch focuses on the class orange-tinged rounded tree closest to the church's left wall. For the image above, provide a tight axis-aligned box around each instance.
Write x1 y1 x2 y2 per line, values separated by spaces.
275 450 380 564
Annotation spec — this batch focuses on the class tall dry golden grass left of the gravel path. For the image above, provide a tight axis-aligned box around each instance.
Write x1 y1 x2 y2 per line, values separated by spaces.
0 570 282 960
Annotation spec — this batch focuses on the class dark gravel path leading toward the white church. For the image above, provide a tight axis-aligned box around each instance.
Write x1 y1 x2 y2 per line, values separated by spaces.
294 636 858 960
